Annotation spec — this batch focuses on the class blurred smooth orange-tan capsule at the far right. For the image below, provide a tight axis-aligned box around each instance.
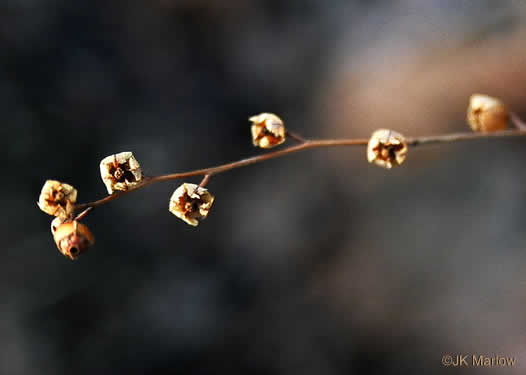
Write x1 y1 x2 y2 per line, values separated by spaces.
467 94 510 133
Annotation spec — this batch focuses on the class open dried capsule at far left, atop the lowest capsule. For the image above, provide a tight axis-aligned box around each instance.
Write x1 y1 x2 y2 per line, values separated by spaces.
37 180 77 218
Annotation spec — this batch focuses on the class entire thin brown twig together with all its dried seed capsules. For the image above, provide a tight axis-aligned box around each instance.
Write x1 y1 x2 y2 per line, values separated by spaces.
37 94 526 259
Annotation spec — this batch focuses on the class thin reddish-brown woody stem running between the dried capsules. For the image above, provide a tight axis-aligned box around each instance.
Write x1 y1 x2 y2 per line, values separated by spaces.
75 128 526 212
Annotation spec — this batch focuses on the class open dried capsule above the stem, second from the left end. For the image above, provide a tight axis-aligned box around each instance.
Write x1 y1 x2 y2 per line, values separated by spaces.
100 152 142 194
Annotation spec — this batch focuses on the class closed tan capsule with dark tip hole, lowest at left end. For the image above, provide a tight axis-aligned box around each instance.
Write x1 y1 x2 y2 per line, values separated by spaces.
51 220 95 260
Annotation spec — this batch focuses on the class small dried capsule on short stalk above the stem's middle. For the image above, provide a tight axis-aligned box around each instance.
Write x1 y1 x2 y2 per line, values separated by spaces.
249 113 285 148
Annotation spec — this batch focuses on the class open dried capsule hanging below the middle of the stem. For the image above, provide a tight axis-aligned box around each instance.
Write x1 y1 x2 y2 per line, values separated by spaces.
168 183 214 227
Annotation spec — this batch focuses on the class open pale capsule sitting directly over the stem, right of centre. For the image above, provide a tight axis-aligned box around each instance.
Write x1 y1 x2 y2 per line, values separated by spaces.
367 129 407 169
